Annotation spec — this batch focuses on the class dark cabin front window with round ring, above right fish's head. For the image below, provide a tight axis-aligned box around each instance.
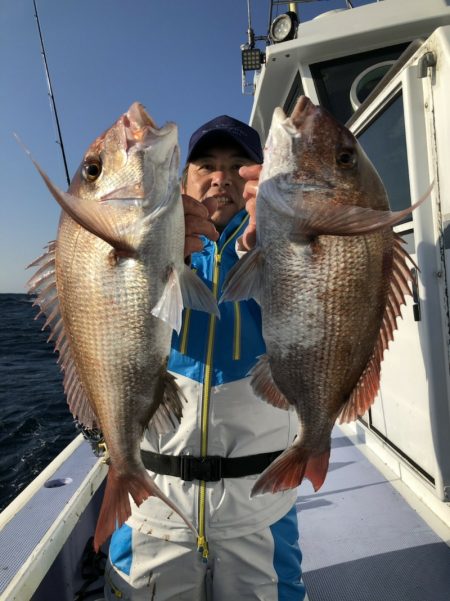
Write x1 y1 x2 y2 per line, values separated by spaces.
310 43 409 123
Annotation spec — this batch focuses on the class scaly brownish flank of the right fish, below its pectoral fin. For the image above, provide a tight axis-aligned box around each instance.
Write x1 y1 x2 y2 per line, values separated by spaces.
262 234 387 419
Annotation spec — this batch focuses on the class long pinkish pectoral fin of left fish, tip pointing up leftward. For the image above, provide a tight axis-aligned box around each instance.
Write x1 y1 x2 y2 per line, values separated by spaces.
31 158 137 256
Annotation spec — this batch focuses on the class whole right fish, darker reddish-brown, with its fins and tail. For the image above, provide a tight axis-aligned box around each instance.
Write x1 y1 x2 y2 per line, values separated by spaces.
221 97 429 495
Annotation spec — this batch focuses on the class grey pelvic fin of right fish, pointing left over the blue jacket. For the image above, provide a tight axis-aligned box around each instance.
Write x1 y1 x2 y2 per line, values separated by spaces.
219 246 264 303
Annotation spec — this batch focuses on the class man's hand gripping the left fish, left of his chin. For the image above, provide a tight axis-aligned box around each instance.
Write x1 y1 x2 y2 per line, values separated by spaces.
182 194 219 258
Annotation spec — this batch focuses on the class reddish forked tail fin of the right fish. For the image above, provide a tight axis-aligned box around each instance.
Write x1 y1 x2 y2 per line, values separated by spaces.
250 444 330 497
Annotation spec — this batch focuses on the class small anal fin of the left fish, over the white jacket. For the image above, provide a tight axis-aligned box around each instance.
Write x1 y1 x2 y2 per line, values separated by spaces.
148 371 186 434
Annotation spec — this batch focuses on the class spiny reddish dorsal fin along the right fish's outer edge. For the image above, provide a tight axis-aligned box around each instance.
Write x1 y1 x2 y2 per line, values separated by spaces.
340 234 417 423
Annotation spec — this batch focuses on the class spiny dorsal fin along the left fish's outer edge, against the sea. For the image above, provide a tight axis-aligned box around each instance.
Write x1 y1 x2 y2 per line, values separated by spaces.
27 242 99 429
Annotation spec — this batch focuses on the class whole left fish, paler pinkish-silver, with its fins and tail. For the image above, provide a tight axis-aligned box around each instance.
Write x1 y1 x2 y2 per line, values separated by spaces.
29 103 217 549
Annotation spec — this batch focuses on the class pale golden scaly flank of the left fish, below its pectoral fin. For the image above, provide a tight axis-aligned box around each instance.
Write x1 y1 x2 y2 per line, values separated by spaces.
56 214 166 460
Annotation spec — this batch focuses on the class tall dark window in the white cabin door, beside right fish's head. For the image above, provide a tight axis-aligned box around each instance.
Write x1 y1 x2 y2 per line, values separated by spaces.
357 93 412 223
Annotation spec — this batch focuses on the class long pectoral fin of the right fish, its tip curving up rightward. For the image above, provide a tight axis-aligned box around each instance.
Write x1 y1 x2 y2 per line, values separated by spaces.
291 183 434 241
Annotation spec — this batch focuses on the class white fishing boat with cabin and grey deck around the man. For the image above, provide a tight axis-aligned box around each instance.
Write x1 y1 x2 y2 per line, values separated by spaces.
0 0 450 601
